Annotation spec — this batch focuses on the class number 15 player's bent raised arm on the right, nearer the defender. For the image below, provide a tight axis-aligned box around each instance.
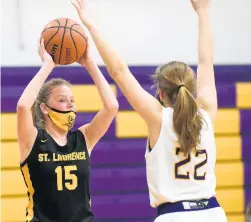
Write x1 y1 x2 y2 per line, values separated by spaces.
79 38 119 151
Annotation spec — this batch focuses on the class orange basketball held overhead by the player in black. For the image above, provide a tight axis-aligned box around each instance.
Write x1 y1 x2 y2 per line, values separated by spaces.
41 18 87 65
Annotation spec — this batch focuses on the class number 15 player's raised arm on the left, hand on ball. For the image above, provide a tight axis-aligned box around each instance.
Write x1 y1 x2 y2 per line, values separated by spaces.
17 39 55 161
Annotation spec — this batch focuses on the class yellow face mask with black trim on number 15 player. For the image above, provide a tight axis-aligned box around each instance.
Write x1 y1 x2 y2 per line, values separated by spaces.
46 105 76 132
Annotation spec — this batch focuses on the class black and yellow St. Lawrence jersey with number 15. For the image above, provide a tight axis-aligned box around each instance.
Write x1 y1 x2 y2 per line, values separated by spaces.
21 129 94 222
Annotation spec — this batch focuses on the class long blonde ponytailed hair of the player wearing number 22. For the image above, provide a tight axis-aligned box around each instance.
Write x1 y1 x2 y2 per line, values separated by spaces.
153 61 203 154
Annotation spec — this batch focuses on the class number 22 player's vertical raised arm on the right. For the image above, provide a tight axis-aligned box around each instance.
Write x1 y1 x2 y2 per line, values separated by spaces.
191 0 218 121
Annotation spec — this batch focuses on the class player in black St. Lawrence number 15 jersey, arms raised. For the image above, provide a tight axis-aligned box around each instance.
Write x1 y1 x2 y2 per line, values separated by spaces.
17 36 118 222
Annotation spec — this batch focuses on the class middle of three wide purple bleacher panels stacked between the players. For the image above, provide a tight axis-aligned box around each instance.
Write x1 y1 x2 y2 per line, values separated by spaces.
91 166 148 195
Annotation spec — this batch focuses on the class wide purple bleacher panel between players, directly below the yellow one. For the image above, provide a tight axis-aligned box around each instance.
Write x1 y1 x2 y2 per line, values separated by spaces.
91 139 146 166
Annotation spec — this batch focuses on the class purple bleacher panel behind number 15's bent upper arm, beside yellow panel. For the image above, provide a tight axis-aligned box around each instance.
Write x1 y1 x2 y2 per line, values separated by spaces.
73 113 115 138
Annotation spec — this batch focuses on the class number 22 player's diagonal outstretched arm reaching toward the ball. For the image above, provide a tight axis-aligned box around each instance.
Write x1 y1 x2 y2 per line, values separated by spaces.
72 0 162 127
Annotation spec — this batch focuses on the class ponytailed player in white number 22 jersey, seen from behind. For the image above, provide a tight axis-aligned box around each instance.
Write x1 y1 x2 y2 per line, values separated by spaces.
72 0 227 222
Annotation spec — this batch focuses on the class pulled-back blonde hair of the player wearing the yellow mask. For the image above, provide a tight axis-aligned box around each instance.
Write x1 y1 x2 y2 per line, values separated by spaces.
31 78 71 128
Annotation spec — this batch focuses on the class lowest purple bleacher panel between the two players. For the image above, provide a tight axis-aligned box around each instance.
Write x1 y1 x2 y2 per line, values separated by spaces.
92 193 156 219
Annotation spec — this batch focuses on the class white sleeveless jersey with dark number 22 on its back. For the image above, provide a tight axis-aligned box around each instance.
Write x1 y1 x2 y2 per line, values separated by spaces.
145 108 216 207
